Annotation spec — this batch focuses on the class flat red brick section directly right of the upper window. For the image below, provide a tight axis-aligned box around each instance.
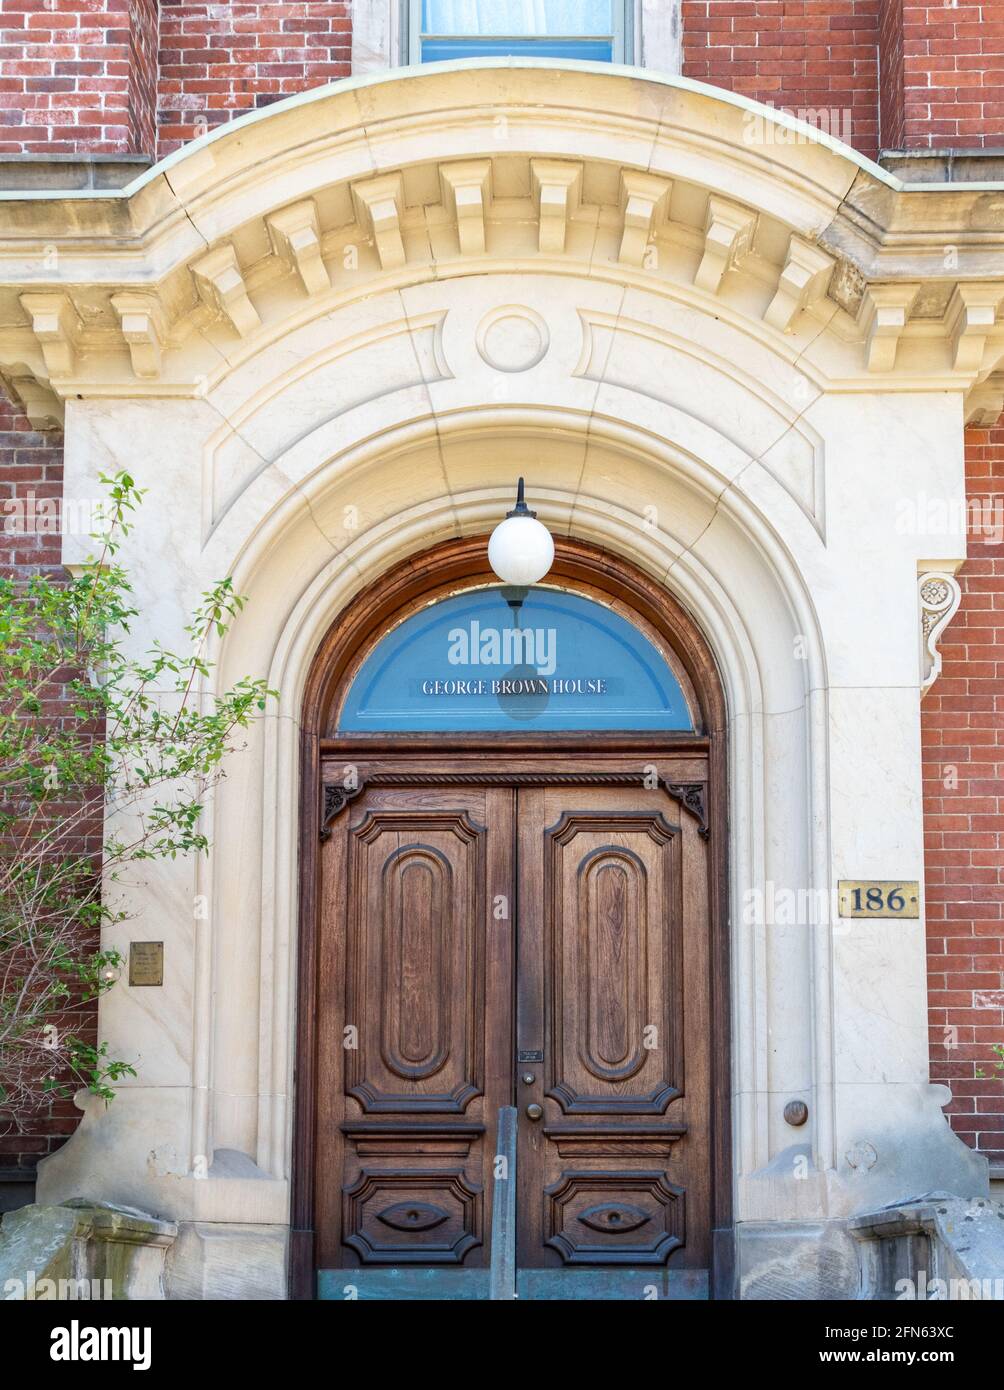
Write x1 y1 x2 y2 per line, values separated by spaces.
683 0 880 157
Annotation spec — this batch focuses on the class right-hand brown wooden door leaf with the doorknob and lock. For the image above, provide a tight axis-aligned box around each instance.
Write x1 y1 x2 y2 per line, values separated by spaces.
516 787 709 1273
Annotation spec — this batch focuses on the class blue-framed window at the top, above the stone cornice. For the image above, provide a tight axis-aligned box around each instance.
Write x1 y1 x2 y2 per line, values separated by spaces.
407 0 631 63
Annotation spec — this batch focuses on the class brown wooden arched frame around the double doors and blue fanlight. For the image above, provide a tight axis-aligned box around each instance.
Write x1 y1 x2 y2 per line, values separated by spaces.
291 535 734 1297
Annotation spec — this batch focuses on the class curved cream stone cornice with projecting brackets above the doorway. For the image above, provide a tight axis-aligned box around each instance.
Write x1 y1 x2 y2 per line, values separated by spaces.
0 64 1004 425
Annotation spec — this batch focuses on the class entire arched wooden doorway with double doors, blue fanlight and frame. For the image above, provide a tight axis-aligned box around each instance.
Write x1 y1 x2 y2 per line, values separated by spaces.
291 537 731 1298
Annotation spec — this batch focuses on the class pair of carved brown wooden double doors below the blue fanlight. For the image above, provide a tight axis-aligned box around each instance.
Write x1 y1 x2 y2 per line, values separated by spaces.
314 753 712 1298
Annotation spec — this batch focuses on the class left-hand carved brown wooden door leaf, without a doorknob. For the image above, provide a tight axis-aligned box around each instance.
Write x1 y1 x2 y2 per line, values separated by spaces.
317 787 513 1269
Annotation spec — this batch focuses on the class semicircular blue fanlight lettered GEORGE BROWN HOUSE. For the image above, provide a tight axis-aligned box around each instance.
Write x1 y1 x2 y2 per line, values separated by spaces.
338 587 694 733
